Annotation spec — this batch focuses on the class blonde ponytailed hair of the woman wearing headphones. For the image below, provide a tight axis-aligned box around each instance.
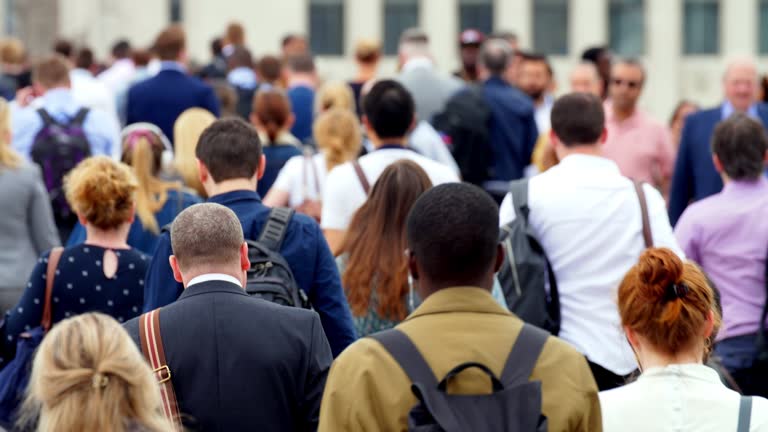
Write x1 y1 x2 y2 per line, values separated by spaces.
122 130 181 234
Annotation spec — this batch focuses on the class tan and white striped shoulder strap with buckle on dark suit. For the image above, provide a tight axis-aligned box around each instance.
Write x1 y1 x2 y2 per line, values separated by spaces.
139 309 181 431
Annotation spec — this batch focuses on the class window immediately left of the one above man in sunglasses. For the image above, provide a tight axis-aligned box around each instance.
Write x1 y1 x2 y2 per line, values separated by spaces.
533 0 568 55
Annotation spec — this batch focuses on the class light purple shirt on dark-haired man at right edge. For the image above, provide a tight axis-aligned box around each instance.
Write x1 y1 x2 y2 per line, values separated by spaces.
675 177 768 340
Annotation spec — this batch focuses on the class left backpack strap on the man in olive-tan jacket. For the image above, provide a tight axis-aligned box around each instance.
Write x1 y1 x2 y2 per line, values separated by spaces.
368 329 438 388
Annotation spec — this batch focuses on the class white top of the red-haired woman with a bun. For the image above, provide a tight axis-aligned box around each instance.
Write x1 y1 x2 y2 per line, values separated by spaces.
600 364 768 432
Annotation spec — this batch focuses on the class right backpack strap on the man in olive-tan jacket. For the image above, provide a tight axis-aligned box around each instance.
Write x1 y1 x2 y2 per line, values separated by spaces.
501 324 549 386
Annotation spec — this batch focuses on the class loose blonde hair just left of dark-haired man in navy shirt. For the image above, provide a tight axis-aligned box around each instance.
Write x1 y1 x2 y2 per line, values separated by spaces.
173 108 216 197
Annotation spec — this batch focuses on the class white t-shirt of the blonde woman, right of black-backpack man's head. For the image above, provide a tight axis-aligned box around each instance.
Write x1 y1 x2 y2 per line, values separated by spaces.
272 153 328 208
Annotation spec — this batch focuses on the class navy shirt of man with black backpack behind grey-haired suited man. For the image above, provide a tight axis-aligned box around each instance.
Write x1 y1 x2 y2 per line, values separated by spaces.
144 190 356 355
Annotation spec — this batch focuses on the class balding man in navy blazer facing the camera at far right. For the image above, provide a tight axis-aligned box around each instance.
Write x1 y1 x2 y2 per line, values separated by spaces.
669 59 768 225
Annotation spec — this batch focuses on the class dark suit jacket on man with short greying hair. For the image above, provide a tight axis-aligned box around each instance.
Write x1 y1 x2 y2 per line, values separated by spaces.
125 281 332 431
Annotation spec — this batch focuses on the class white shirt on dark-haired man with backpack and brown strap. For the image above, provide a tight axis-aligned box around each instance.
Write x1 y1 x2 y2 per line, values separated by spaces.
500 154 683 375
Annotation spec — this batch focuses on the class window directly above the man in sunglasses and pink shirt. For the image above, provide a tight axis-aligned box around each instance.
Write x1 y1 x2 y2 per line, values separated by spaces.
608 0 645 56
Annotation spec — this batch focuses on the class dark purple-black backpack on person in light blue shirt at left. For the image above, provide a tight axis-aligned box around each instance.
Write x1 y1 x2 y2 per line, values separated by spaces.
30 108 91 241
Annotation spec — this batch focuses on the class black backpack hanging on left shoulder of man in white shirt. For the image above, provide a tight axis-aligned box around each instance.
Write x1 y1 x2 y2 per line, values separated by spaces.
498 180 560 335
